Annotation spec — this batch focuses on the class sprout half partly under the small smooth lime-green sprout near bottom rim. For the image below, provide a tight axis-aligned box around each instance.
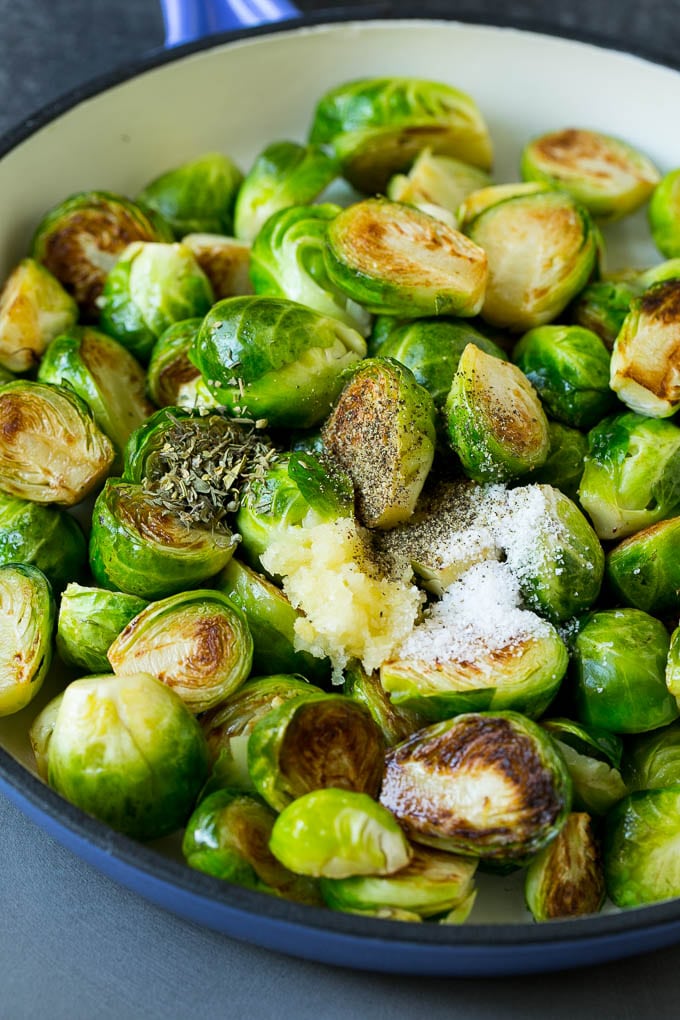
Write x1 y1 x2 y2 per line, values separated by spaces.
320 847 477 917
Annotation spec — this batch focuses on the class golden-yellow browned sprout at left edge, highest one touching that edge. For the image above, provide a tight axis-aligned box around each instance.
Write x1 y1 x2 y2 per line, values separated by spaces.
0 258 77 381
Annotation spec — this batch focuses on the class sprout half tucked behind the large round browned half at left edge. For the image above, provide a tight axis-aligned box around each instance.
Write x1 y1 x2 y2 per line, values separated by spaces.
38 326 153 454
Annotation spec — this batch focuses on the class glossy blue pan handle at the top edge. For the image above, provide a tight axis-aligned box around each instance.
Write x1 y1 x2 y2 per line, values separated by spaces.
160 0 300 47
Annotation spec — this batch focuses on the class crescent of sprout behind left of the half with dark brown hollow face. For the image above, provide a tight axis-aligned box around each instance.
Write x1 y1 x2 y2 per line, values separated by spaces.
201 673 323 791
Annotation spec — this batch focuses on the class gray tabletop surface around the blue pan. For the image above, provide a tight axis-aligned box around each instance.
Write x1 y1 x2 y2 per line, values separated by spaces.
0 0 680 1020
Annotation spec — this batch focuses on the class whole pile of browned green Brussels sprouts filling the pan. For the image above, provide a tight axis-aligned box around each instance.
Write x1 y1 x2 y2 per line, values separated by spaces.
0 79 680 923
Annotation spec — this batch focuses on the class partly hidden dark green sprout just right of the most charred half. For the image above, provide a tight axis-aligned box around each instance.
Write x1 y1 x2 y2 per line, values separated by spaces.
541 719 628 815
